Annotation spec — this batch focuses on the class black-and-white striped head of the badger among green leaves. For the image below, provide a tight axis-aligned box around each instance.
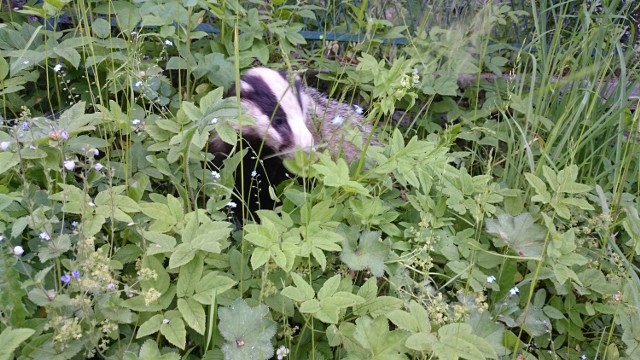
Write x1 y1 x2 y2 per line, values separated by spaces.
231 68 314 154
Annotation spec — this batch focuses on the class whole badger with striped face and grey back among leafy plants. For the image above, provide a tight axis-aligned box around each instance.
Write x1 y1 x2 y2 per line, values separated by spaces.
209 67 371 221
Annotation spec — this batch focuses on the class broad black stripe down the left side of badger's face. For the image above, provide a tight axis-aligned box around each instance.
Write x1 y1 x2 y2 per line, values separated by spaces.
240 75 292 150
